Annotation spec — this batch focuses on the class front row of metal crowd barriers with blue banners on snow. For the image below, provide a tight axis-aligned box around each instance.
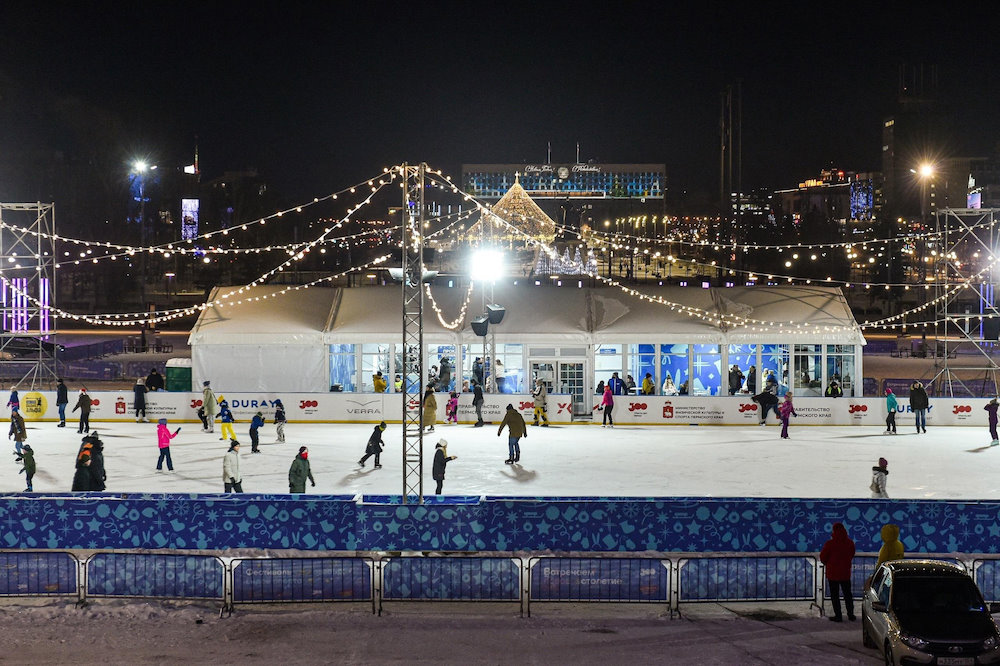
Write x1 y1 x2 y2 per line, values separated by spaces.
0 550 1000 617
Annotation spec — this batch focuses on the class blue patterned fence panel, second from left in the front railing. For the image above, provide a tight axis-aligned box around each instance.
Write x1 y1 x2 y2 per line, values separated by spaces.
87 553 225 599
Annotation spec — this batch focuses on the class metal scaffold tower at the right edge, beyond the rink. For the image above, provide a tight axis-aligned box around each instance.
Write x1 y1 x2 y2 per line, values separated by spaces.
932 208 1000 397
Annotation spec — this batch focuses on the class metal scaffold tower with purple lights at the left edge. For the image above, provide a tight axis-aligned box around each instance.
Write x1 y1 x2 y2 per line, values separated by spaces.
0 203 58 389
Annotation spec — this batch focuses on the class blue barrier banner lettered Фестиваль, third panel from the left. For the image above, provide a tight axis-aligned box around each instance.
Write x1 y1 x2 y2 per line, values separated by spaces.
233 557 372 603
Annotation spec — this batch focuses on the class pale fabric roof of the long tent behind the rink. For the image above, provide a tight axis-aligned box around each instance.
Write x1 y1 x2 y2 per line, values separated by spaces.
190 280 865 345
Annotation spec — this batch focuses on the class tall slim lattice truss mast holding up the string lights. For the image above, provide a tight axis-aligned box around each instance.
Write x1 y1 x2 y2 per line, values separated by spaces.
400 163 427 504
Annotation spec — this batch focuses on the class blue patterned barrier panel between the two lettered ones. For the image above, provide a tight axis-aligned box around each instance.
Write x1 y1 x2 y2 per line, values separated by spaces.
382 557 521 601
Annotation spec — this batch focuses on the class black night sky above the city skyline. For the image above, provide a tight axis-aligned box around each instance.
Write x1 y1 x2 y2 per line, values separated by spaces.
0 0 1000 198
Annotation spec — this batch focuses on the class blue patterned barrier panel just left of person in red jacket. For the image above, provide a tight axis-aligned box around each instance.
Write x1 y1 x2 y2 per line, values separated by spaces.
679 557 816 601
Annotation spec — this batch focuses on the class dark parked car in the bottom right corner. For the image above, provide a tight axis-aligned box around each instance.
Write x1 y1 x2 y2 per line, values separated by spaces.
861 560 1000 666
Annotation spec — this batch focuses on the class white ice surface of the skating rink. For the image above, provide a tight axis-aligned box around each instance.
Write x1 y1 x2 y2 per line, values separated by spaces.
0 420 1000 499
